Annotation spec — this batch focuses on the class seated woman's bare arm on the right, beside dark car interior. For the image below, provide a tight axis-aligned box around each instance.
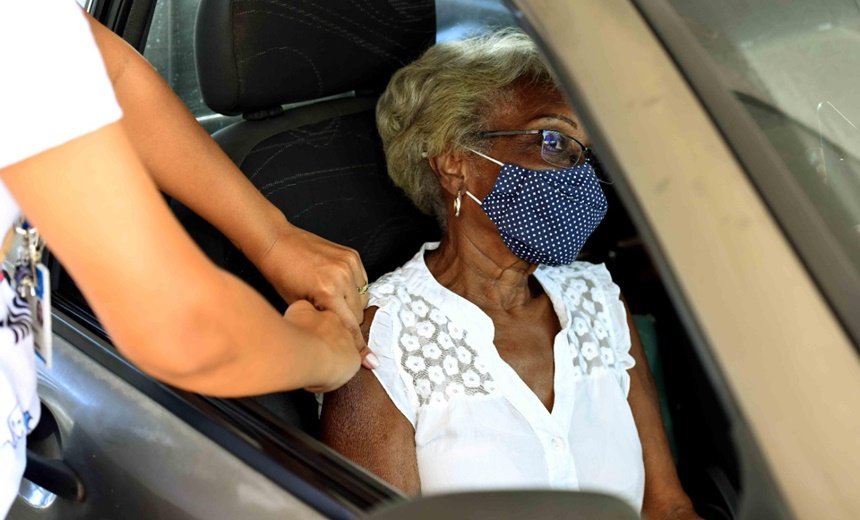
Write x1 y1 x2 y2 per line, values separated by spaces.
625 304 699 520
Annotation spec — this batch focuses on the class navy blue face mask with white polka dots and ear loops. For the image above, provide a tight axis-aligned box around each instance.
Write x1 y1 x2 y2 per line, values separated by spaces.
466 148 608 265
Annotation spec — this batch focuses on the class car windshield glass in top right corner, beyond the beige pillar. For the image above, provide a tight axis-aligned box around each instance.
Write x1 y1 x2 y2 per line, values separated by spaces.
671 0 860 280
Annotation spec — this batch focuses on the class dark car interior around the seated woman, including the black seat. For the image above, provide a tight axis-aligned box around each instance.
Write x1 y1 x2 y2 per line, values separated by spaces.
52 0 743 519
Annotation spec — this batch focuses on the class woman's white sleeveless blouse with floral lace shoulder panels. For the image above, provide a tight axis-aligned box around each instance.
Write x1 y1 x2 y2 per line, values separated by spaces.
368 243 645 511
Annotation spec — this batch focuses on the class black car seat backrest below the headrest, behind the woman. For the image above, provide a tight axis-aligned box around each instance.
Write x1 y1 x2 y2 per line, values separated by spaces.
174 94 438 310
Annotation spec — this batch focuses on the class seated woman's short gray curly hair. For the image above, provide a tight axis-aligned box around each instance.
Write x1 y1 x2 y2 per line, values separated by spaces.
376 29 558 223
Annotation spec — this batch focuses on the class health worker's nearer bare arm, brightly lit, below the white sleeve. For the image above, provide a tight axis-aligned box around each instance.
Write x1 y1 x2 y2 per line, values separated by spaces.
0 123 362 396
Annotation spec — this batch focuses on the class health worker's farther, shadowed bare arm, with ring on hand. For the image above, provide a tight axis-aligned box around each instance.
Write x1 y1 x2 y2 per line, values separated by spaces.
88 16 367 341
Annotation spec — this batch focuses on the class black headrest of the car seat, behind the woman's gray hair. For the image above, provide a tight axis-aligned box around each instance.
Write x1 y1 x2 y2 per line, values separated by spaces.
195 0 436 115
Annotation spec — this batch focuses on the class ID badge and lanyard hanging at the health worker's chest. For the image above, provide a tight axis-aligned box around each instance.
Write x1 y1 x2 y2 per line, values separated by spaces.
3 218 53 368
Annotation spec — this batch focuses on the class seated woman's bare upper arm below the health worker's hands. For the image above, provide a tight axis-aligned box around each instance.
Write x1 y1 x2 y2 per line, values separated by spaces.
321 308 421 495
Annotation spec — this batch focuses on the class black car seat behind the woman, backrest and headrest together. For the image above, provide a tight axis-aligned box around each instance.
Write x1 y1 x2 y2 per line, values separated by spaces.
177 0 439 432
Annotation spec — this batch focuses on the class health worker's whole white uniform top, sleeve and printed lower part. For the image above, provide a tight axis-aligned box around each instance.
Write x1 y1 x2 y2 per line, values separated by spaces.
0 0 122 517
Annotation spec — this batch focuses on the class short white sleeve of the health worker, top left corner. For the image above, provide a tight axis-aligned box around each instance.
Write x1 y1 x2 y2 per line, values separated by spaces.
0 0 122 169
